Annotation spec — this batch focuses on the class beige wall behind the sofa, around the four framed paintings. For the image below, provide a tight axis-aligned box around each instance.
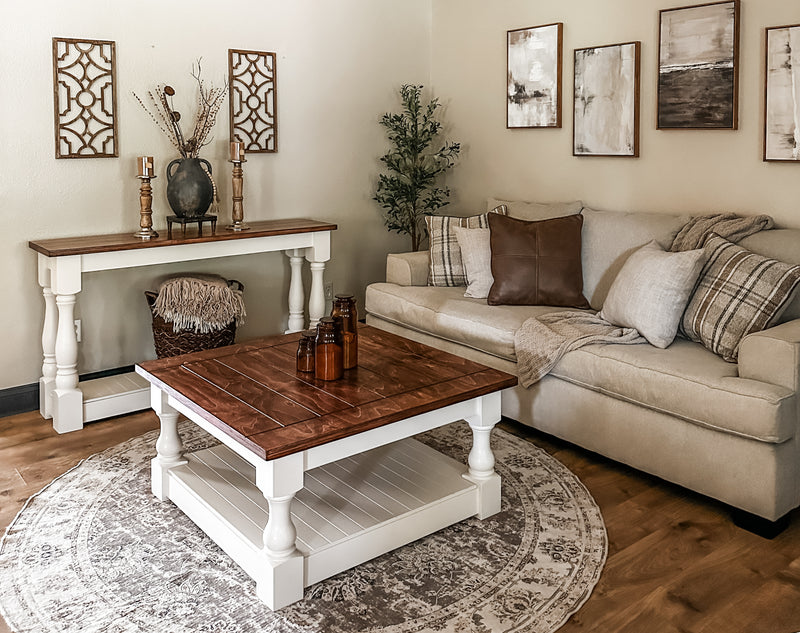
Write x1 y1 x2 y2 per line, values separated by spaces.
431 0 800 222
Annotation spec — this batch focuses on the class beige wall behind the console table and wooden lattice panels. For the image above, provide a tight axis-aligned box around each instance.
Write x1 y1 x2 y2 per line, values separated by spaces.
0 0 431 389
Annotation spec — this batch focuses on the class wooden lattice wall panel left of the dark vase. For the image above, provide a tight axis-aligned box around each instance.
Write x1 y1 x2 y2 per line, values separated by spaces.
53 37 119 158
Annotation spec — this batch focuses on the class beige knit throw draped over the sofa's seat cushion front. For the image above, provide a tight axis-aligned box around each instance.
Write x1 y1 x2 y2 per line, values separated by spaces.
514 310 646 387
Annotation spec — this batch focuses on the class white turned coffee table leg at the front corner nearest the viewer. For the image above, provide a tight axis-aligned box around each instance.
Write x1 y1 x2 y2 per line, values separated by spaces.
255 453 305 611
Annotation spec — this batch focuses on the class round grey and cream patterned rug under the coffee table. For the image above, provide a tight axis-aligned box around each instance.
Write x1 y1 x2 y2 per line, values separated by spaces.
0 422 607 633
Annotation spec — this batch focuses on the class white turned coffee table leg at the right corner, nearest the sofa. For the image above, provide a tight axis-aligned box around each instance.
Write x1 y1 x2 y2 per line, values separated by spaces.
464 392 500 519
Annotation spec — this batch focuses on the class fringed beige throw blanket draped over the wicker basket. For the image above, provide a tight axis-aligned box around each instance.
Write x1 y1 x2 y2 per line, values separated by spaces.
153 274 247 334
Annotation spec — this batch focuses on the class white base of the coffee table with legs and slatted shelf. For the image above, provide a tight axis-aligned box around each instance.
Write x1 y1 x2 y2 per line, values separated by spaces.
152 387 500 610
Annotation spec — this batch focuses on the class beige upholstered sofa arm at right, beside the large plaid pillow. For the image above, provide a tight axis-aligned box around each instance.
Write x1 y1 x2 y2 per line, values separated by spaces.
739 319 800 391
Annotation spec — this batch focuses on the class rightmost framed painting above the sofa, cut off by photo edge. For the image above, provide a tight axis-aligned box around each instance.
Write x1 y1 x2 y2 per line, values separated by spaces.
764 24 800 163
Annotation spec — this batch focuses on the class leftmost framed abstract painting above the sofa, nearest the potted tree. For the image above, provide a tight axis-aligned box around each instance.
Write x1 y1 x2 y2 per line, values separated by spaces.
506 22 564 129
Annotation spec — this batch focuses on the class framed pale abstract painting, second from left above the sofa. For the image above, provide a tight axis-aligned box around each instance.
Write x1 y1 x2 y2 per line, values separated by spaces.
572 41 641 158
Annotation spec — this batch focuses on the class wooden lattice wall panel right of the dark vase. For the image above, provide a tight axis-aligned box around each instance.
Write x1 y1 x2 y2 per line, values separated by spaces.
228 49 278 154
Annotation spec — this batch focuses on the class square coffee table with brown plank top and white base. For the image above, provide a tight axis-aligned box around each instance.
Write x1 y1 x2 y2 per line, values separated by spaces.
136 326 517 610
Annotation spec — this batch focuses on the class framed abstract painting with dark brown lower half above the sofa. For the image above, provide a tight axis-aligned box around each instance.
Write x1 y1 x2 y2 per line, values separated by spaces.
657 0 739 130
